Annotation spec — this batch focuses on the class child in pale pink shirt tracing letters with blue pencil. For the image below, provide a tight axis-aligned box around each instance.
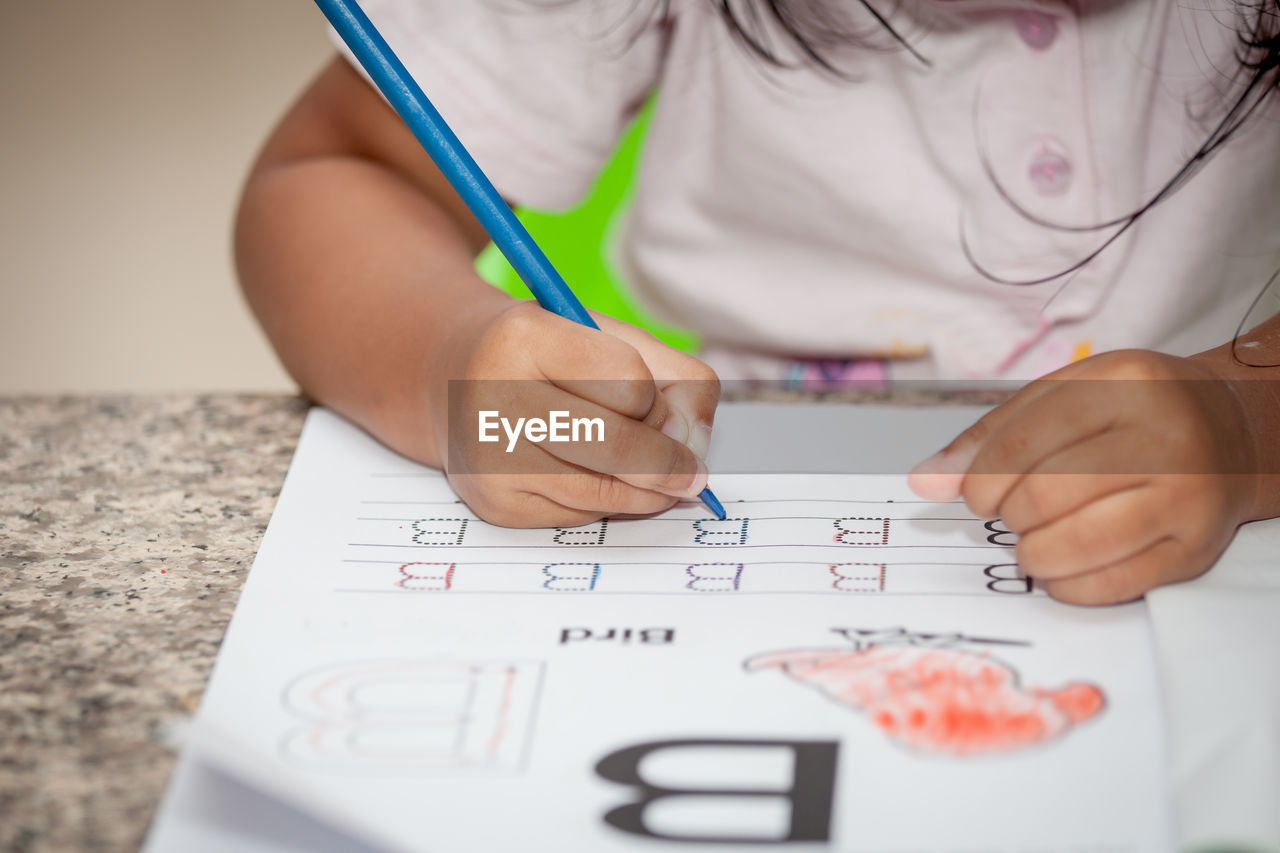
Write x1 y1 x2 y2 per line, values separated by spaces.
237 0 1280 603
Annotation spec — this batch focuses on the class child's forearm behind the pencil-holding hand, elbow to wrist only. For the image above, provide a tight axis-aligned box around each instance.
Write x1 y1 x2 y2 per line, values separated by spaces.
237 158 507 466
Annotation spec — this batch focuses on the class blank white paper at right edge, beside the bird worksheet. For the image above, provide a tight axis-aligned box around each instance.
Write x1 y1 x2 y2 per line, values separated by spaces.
1147 519 1280 850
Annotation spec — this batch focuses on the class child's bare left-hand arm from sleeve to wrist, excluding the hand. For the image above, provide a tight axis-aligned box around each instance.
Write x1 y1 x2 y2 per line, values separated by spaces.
236 60 509 466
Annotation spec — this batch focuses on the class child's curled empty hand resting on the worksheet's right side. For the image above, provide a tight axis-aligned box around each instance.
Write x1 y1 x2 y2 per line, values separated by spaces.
909 350 1258 605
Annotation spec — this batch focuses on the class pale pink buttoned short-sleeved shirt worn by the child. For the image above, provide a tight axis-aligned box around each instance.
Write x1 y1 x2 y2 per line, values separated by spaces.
332 0 1280 378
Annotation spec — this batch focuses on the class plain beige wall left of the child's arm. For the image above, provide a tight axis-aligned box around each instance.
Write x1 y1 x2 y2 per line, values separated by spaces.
0 0 332 393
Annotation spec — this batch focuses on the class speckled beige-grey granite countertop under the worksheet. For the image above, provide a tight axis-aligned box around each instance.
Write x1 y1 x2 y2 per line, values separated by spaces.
0 391 988 853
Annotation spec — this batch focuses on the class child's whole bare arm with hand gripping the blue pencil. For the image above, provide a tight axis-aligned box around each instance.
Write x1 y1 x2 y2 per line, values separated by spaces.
236 59 718 526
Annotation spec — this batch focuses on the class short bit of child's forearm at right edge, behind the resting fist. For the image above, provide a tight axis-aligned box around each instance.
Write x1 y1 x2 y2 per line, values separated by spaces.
1192 307 1280 519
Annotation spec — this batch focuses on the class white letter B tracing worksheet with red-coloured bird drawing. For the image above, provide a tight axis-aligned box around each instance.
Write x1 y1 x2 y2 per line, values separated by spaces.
148 405 1174 853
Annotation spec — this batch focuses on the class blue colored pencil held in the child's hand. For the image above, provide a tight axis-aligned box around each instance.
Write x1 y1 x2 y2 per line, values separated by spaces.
316 0 724 519
